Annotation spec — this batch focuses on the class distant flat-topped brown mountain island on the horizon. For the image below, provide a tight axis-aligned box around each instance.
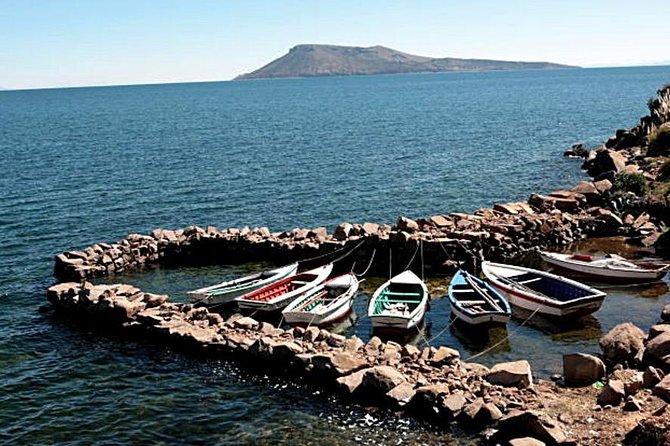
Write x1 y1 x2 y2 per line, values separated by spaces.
235 45 578 79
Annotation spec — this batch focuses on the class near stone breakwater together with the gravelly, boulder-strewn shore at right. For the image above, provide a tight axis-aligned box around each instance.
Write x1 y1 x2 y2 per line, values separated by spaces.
47 282 670 444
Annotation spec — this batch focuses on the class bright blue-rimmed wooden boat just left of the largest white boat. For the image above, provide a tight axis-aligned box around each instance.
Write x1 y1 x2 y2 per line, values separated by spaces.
447 270 512 325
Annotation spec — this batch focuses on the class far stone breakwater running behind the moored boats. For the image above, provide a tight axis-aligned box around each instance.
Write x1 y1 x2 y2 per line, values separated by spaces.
54 192 658 281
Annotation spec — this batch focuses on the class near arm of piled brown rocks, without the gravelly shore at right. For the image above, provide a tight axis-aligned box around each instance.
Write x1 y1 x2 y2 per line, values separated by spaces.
47 283 566 444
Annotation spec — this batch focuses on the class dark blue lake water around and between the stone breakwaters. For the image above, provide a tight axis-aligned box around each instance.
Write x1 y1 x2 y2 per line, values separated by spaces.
0 67 670 444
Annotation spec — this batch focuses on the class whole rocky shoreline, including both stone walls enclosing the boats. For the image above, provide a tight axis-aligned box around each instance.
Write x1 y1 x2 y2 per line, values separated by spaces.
47 87 670 445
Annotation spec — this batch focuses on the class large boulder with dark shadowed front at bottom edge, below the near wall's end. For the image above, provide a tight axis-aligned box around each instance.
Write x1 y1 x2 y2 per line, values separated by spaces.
492 409 566 445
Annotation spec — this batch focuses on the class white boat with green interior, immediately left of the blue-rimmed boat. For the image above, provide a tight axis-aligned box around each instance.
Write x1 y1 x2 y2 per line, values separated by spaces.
368 271 428 330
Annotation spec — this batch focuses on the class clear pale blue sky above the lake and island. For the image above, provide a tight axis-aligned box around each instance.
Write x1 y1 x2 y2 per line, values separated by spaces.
0 0 670 88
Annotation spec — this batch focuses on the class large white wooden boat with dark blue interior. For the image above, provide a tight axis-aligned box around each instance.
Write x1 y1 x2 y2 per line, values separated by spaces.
482 261 606 317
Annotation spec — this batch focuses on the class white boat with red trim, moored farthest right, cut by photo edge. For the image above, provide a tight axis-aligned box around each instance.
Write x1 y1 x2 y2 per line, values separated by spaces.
540 251 670 283
